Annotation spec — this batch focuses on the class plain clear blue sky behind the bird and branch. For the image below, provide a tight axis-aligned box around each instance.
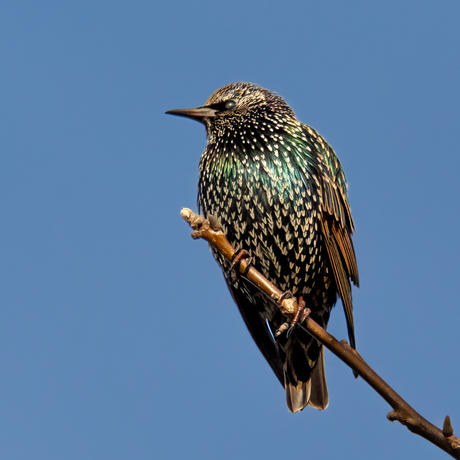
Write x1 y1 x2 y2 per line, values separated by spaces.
0 0 460 460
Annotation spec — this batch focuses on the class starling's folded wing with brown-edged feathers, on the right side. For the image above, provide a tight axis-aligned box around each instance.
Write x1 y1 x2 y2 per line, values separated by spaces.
320 140 359 347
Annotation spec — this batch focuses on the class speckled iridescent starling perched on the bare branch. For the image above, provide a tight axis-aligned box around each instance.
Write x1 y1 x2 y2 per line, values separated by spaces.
166 82 359 413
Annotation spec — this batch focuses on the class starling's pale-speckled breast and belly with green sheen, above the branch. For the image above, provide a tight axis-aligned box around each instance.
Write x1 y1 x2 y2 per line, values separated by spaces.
199 144 323 294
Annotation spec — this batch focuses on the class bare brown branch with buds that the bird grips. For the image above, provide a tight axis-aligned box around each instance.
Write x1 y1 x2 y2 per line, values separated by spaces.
181 208 460 459
